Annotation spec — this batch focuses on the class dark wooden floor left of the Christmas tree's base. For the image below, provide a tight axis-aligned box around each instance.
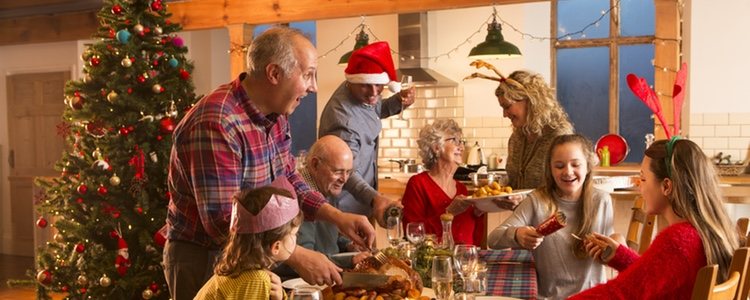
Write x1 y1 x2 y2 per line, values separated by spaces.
0 254 62 300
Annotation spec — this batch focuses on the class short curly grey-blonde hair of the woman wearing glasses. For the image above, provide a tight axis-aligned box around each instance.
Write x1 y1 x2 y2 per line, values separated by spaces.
417 119 464 170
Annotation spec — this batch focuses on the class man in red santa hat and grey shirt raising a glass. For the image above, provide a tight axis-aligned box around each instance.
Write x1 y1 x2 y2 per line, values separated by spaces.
318 42 415 225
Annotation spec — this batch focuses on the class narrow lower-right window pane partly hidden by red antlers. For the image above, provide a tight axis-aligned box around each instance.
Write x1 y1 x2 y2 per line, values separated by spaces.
619 44 654 162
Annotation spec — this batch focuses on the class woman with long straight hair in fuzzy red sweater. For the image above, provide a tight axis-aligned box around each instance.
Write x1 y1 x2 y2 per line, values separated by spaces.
571 137 739 299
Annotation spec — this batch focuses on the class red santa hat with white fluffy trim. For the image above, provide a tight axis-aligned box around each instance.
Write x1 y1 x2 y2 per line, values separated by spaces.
344 42 401 93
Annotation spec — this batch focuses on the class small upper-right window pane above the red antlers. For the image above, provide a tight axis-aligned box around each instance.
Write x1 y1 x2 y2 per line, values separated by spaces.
620 0 656 36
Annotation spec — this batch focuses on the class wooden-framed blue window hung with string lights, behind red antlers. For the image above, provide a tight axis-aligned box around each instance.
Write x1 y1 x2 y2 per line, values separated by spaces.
552 0 655 162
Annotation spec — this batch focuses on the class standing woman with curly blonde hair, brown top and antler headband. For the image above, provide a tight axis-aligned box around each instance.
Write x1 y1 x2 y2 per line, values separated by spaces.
466 60 573 189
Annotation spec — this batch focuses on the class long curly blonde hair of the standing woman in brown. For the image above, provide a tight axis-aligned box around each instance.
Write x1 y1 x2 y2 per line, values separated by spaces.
495 71 573 136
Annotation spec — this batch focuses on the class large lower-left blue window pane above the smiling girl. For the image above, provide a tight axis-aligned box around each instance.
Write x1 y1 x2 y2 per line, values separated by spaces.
557 47 609 142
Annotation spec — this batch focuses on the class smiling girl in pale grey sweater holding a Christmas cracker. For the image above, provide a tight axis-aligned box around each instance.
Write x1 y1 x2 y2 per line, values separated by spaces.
487 134 613 299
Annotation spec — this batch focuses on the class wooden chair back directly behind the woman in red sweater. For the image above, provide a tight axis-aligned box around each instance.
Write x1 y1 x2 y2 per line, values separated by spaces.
692 265 740 300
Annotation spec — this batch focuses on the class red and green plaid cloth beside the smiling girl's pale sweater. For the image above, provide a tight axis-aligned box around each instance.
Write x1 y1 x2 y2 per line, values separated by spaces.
479 249 537 299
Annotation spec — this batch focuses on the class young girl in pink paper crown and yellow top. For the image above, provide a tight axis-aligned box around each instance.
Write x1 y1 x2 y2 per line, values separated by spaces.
195 181 302 300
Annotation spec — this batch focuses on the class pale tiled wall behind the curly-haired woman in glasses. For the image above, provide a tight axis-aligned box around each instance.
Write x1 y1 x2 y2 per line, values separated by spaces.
378 86 512 172
